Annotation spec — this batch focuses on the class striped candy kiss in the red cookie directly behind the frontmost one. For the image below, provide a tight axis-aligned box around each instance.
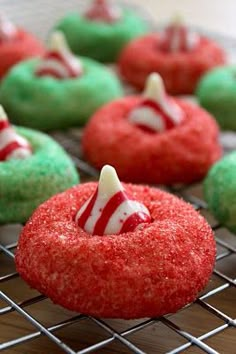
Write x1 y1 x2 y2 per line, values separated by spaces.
128 73 184 132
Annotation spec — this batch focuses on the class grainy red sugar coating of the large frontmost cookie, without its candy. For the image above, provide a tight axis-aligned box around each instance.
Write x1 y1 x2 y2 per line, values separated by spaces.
16 183 216 319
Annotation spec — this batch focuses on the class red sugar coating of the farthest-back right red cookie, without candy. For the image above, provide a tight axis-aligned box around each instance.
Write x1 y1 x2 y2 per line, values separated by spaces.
119 34 225 95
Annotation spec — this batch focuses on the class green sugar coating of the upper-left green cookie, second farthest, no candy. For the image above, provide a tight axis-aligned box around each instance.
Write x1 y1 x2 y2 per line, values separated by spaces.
0 58 122 130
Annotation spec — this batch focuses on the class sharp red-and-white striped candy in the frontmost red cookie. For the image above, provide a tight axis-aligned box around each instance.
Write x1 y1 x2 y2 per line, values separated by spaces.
75 165 151 235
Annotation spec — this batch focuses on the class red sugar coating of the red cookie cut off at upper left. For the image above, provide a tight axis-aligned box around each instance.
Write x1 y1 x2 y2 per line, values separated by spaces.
0 29 44 78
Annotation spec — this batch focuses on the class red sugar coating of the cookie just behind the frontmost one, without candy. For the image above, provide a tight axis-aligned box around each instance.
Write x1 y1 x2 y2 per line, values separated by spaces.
82 97 221 184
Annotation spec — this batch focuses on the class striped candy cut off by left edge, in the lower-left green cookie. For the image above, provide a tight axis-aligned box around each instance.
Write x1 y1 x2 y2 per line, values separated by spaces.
0 106 32 161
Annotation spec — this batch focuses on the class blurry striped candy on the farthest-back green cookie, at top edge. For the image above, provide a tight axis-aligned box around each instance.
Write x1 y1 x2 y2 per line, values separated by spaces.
85 0 122 23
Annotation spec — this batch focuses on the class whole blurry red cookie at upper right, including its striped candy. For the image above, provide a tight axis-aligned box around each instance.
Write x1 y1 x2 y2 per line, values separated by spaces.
118 16 225 95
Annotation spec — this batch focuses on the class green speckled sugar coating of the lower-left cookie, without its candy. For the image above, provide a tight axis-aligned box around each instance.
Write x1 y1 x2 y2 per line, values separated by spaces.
0 127 79 224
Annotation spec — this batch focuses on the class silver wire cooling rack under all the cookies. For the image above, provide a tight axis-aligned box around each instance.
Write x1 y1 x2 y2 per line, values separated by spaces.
0 0 236 354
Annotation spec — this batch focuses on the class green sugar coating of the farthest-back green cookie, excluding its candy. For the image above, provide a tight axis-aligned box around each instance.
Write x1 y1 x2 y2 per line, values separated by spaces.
55 11 147 62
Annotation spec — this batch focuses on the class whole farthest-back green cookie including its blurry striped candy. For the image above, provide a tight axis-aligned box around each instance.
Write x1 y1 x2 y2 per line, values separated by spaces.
55 0 147 62
